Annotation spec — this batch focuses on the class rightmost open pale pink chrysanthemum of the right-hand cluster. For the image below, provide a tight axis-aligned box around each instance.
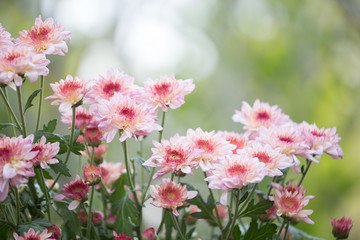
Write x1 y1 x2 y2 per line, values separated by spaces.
299 122 344 163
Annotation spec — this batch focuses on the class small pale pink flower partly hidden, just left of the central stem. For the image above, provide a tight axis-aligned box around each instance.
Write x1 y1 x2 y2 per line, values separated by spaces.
100 161 126 191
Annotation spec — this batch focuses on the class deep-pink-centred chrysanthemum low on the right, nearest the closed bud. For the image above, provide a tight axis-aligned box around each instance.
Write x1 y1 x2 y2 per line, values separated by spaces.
269 182 315 224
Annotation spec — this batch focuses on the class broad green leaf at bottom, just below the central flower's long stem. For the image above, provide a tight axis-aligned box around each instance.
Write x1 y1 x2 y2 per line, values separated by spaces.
112 194 138 237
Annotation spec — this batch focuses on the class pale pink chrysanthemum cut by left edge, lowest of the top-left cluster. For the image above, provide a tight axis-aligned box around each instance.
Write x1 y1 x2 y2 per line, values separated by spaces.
0 44 50 89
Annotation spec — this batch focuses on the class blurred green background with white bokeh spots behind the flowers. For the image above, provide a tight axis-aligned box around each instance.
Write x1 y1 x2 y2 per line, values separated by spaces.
0 0 360 239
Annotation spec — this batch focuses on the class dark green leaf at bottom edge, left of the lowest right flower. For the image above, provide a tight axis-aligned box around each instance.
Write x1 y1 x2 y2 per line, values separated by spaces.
244 219 277 240
